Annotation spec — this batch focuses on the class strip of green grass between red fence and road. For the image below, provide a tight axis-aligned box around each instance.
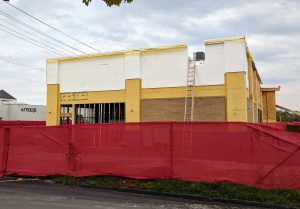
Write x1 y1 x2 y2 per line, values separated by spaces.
53 176 300 208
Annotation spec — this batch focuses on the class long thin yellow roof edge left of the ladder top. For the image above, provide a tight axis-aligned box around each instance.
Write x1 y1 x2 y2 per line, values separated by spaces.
47 44 187 64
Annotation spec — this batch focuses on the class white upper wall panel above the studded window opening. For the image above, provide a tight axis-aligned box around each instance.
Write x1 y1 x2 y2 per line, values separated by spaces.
58 56 125 93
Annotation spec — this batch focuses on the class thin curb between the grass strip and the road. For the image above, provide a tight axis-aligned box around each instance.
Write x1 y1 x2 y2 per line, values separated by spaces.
75 184 297 209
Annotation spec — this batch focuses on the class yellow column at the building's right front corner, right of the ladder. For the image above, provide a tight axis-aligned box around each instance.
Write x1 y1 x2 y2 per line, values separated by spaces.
225 72 247 122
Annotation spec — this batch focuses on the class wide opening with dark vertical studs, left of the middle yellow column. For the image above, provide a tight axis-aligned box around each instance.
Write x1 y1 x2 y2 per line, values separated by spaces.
76 103 125 124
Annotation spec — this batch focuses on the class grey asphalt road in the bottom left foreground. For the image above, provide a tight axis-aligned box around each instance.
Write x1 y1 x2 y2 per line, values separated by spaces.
0 178 258 209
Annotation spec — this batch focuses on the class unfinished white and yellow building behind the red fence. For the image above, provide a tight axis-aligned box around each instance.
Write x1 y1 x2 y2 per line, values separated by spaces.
47 37 279 125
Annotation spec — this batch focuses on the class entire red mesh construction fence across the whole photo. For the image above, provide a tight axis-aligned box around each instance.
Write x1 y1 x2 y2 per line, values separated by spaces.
0 122 300 190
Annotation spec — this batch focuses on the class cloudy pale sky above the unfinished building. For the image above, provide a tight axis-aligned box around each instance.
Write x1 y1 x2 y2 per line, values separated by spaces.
0 0 300 110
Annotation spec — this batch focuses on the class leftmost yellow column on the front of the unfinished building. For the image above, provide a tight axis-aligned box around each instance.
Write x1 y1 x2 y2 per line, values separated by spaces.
46 84 60 126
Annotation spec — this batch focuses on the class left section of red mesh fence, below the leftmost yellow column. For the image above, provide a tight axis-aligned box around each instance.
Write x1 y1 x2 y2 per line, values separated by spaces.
5 127 71 176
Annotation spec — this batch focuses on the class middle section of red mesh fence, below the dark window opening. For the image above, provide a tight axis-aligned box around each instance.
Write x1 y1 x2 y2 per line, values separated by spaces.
72 124 171 179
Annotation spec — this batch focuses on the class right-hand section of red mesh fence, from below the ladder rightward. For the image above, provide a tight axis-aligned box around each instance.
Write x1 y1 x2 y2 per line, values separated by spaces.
173 123 300 190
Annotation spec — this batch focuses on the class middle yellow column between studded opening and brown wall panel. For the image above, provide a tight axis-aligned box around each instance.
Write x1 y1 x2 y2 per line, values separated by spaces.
125 79 142 122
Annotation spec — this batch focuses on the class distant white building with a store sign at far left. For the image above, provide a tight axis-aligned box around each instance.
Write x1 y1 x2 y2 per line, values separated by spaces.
0 90 46 121
